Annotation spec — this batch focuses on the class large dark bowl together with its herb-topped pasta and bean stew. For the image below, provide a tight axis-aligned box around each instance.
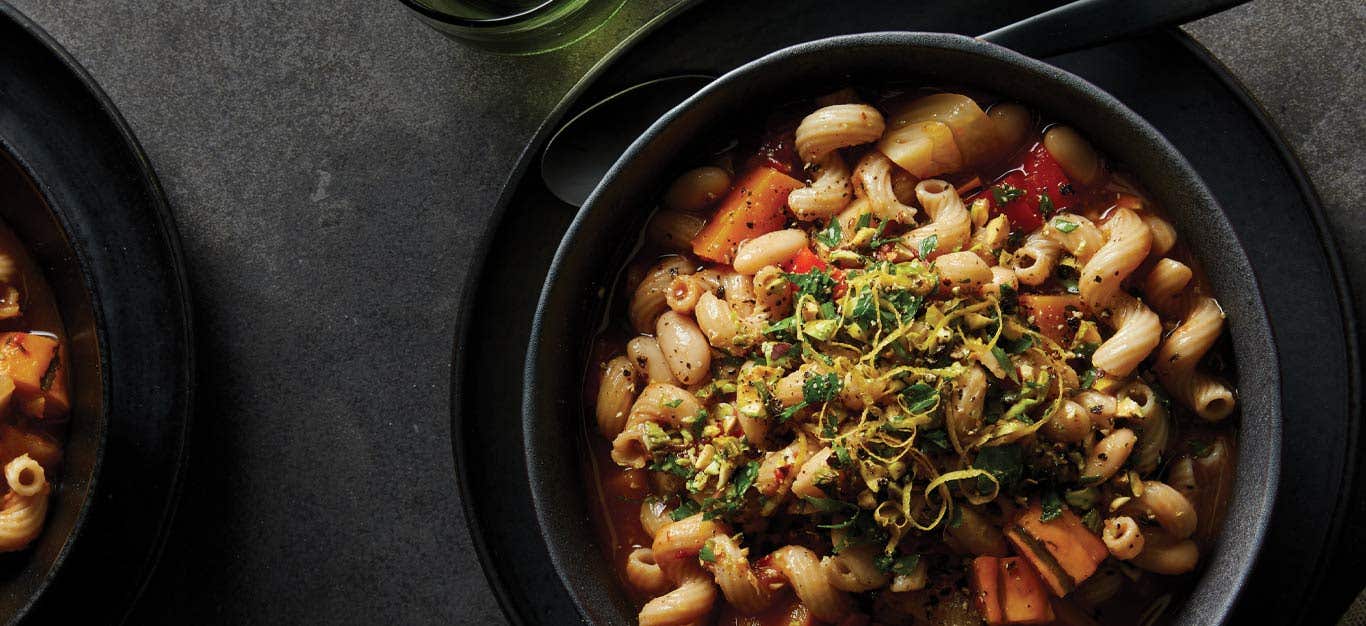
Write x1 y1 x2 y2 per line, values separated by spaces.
525 34 1279 625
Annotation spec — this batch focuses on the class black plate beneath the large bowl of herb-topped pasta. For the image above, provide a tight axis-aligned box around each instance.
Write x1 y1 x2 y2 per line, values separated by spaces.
452 0 1359 623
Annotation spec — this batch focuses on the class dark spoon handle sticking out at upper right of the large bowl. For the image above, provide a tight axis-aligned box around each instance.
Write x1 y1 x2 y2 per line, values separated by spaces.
978 0 1247 59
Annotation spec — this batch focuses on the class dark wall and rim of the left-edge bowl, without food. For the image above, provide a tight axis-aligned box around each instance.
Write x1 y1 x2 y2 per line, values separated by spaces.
0 145 105 622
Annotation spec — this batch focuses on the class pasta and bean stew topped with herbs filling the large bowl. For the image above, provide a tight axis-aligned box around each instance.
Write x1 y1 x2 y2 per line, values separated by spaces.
587 89 1236 626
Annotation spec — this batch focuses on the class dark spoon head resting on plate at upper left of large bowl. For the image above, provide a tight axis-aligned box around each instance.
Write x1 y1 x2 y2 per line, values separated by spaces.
541 74 716 206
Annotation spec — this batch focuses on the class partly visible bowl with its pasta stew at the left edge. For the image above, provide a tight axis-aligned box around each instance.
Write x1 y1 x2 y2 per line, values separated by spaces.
0 150 105 621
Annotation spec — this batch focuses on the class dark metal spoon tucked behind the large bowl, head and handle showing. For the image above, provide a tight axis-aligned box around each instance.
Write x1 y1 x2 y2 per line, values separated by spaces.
541 0 1247 206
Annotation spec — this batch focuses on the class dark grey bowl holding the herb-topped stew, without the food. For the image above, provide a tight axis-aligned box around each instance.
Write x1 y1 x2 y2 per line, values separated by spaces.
522 33 1281 625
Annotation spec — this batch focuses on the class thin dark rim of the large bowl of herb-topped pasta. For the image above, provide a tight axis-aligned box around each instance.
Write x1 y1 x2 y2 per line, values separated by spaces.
522 31 1283 622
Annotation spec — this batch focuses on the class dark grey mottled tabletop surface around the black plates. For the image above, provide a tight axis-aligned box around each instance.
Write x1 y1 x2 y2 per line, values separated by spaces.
11 0 1366 623
